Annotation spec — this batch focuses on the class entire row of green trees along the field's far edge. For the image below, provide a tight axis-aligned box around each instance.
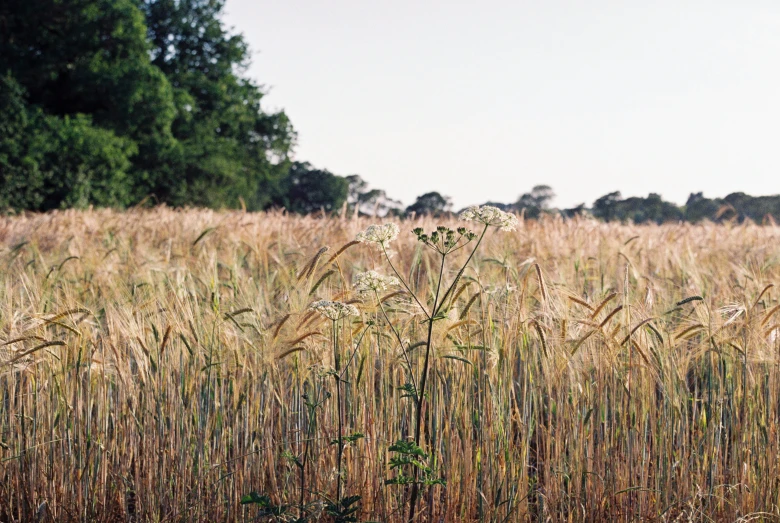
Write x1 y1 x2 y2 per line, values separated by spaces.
0 0 780 223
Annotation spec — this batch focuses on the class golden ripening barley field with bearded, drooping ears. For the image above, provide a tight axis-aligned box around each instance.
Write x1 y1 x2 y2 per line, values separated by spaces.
0 208 780 522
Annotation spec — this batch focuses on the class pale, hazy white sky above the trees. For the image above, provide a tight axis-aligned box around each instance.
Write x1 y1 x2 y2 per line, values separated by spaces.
224 0 780 209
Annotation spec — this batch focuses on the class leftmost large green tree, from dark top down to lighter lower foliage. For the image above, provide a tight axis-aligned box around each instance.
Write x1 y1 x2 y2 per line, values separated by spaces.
0 0 175 210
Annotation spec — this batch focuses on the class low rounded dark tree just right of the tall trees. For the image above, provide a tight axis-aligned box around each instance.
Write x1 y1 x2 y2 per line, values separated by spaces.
273 162 349 214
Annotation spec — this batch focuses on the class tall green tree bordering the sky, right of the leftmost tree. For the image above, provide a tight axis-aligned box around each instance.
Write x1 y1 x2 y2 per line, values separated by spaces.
136 0 295 210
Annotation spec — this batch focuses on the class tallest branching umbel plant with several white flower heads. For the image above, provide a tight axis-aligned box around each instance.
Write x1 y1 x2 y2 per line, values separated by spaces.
355 206 517 523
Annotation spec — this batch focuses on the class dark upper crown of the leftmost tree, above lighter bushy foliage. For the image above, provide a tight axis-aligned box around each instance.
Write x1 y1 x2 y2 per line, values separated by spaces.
0 0 175 144
